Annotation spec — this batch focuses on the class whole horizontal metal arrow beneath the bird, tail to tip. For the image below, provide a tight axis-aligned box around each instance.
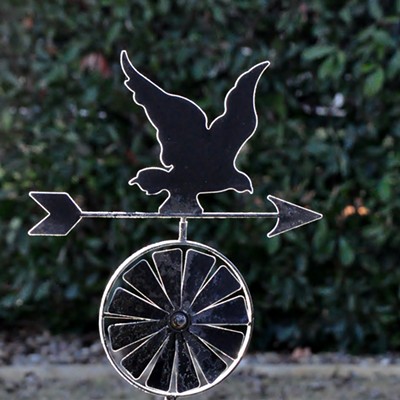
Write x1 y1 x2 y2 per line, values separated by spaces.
28 192 322 238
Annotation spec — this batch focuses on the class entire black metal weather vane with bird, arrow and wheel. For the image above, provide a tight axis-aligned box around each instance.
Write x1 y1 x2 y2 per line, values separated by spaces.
29 51 322 399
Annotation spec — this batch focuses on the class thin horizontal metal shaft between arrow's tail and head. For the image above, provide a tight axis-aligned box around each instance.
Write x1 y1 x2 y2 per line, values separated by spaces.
81 211 279 219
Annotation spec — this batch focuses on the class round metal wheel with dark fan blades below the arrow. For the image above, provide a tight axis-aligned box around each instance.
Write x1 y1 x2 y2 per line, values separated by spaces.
99 241 253 396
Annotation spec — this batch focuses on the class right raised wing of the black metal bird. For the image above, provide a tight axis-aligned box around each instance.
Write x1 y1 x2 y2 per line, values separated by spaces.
210 61 269 160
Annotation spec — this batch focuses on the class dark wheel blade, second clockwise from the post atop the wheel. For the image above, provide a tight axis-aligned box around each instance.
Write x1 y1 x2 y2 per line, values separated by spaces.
191 266 241 313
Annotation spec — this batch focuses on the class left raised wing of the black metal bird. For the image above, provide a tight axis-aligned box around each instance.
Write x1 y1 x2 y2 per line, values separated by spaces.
121 51 207 166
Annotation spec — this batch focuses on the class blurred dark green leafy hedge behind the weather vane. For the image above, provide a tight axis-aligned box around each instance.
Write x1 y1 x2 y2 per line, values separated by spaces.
0 0 400 352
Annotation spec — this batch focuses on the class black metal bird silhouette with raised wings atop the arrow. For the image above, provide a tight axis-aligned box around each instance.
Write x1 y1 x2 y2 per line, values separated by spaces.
121 51 269 214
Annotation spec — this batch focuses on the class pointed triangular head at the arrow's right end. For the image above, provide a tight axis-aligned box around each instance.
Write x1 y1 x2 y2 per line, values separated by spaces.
267 195 322 238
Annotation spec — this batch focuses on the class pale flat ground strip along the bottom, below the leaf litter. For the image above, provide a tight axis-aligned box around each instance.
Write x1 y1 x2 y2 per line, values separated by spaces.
0 363 400 400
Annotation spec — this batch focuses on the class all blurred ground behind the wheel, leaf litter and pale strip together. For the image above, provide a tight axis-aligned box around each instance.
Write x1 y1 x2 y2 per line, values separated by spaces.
0 327 400 400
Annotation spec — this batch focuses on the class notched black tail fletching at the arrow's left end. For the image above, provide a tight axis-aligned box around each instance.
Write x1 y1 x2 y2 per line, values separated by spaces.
28 192 82 236
